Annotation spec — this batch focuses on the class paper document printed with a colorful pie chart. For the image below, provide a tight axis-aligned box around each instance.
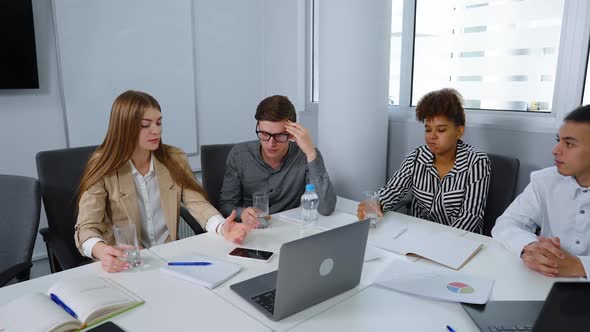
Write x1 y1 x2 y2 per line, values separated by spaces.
375 260 494 304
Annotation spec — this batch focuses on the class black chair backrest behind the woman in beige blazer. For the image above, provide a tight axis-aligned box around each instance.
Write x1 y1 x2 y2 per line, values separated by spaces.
37 146 97 272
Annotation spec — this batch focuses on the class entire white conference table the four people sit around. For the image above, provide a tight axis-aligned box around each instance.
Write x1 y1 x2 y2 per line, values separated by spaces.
0 197 572 332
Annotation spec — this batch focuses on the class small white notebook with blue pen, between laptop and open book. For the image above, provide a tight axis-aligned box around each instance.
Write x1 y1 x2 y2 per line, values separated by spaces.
160 255 242 289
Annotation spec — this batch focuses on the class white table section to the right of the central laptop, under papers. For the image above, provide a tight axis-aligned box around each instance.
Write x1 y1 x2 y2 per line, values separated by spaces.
291 208 577 332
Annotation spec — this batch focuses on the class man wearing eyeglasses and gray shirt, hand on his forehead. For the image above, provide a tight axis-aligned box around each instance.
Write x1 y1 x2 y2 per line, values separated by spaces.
219 96 336 227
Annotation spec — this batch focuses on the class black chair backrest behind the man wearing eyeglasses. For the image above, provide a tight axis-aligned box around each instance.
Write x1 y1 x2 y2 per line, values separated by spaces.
201 144 234 210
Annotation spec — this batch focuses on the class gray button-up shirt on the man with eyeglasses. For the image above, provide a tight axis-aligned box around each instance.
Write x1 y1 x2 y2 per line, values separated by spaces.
219 141 336 217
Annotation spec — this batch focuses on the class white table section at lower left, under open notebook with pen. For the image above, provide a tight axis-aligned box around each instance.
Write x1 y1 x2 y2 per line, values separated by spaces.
0 250 270 331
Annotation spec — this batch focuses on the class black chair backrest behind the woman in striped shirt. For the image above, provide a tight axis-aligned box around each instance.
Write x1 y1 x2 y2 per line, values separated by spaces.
483 153 520 236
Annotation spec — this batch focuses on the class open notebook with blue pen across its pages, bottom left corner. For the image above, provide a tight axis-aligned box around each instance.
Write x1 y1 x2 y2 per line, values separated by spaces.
0 276 144 332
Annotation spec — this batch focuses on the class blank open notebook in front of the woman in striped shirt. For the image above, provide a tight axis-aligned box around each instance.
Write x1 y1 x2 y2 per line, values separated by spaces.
369 222 482 270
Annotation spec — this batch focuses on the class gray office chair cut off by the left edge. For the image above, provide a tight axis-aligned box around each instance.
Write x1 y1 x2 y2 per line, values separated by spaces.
0 175 41 287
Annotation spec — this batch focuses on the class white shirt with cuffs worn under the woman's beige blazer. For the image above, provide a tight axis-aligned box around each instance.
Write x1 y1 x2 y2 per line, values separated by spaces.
82 156 225 258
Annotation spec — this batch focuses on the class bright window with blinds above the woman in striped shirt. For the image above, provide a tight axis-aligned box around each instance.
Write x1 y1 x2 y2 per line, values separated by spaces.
412 0 564 112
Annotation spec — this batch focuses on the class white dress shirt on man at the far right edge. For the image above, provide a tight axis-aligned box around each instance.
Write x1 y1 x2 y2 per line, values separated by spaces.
492 167 590 276
